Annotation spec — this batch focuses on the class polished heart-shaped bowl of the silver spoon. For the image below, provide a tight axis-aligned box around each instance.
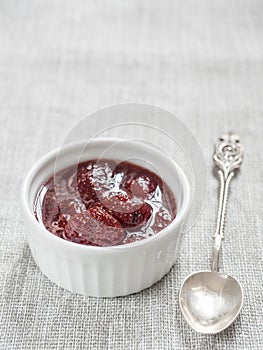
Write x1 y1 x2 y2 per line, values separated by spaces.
179 271 243 334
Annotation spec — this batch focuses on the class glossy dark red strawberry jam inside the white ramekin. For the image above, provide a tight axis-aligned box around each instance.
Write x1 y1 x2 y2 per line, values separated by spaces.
34 159 177 247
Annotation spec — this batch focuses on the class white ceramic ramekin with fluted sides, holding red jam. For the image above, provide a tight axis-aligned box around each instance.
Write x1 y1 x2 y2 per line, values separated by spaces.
21 138 190 297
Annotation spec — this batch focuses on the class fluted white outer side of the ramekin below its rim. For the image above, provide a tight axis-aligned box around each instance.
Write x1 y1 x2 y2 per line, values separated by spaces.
28 223 184 297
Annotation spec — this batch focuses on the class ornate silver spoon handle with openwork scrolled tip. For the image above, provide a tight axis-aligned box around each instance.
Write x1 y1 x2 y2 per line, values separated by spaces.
212 133 243 271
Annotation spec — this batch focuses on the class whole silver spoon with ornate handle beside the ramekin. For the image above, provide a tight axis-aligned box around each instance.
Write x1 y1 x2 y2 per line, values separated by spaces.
179 133 243 334
